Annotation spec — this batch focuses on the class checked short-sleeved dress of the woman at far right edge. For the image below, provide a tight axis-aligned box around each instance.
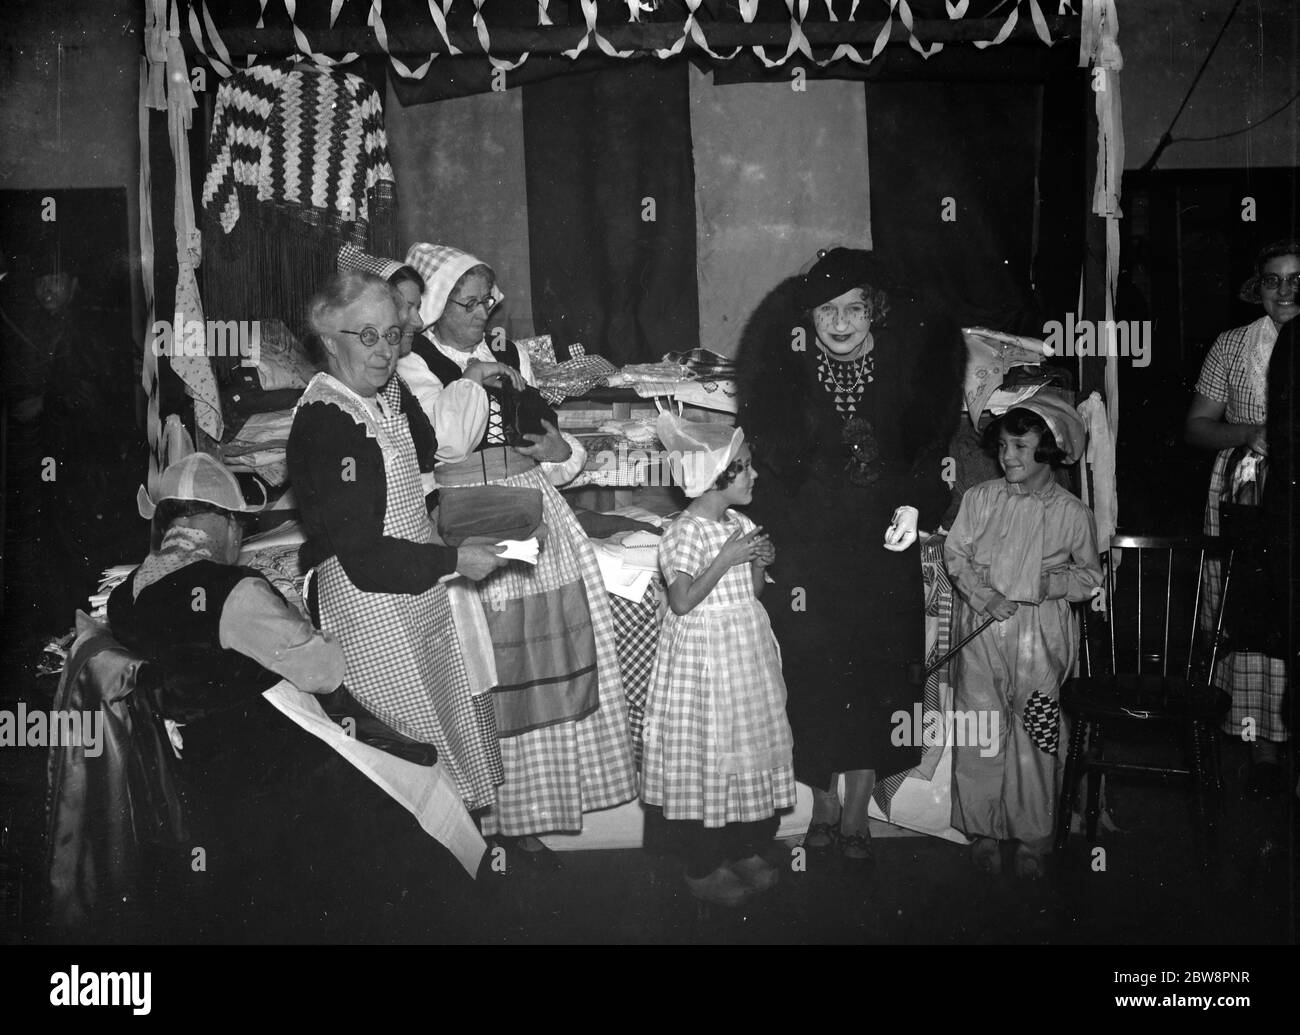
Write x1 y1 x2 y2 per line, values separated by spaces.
1196 316 1290 742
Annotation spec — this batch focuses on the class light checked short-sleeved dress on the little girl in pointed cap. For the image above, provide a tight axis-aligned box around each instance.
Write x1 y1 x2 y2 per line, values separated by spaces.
641 511 794 827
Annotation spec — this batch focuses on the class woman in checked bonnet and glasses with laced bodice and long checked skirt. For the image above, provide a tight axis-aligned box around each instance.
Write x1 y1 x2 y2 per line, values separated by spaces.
398 243 634 861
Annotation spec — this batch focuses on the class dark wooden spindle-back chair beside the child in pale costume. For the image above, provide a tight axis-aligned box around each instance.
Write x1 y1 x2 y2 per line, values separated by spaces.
1056 536 1232 866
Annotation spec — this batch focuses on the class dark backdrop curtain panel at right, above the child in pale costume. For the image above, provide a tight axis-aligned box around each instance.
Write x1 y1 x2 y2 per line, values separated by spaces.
866 74 1083 335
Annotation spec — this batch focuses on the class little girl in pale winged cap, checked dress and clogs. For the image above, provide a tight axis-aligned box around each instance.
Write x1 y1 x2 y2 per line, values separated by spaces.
642 416 794 906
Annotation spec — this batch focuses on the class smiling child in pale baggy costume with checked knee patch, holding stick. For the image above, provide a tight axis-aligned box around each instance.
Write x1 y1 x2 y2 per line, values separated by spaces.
944 395 1101 878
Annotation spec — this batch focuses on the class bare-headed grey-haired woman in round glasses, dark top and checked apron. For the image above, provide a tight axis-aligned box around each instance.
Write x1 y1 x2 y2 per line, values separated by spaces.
287 270 506 807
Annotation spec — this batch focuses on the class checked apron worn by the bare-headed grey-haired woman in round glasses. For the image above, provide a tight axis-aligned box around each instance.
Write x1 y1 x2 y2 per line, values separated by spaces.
303 377 502 809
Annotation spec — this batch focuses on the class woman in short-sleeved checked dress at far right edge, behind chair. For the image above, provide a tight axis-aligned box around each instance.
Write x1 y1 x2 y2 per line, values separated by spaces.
1184 241 1300 793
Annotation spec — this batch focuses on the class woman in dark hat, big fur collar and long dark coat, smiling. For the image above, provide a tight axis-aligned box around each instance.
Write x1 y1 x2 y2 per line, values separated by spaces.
737 248 966 862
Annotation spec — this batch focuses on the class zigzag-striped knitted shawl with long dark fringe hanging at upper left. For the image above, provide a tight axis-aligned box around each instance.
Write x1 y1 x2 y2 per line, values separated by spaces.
203 62 397 348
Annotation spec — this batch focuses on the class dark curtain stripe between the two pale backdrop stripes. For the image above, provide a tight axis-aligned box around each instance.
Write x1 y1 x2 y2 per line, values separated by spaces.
524 59 699 365
